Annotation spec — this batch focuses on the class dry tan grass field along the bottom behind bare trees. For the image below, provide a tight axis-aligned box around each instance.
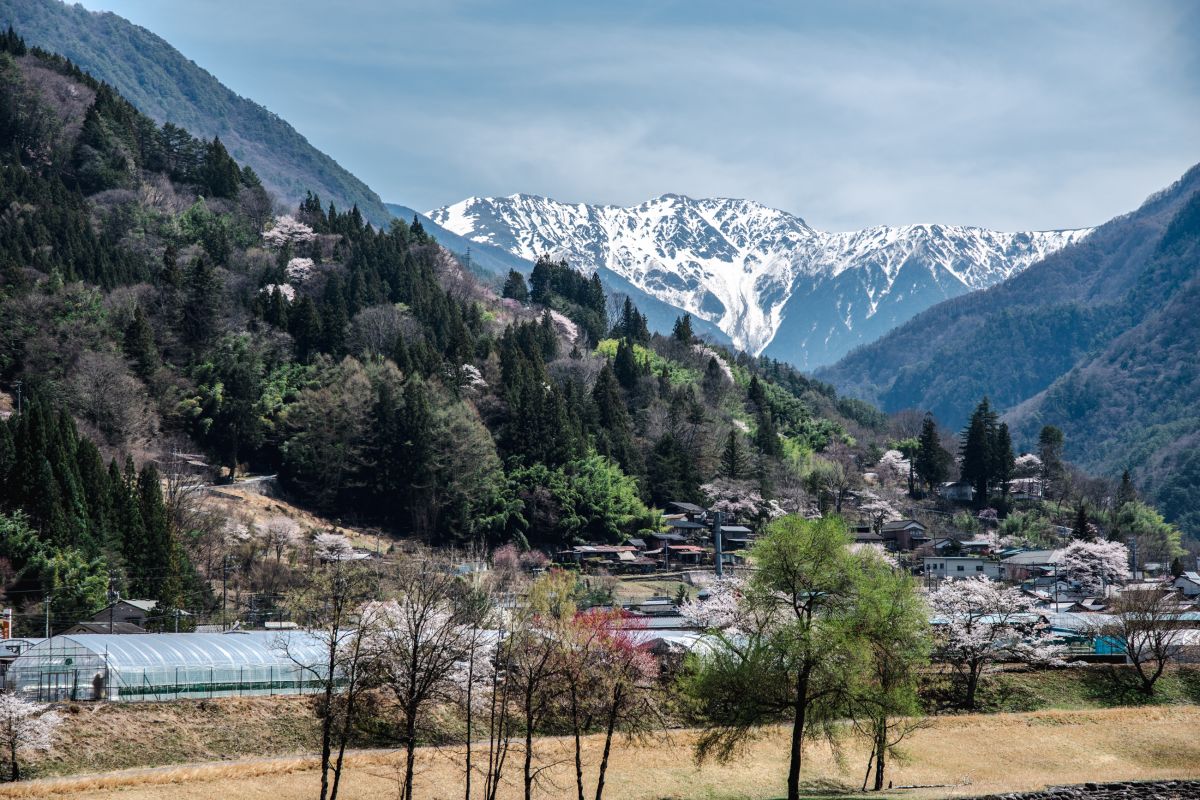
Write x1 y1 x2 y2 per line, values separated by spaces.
0 706 1200 800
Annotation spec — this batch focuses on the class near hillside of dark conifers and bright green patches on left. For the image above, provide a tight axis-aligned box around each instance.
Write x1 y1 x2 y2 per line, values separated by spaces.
0 34 886 619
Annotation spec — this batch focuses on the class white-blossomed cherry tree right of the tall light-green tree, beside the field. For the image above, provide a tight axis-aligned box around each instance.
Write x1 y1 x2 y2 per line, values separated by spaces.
929 577 1063 709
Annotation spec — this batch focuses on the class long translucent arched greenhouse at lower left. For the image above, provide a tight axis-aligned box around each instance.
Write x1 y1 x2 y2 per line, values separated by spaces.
5 631 336 703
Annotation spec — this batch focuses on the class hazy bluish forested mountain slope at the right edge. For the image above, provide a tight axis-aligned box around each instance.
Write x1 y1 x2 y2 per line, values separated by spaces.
818 167 1200 531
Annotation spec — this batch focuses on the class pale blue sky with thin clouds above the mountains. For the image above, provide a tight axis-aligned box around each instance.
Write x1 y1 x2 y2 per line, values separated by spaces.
77 0 1200 230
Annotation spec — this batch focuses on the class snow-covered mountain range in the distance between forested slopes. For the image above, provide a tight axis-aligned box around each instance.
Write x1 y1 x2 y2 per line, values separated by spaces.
427 194 1088 368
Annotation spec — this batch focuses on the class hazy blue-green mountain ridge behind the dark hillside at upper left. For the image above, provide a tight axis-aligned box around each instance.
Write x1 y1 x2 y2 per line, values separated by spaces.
0 0 390 225
